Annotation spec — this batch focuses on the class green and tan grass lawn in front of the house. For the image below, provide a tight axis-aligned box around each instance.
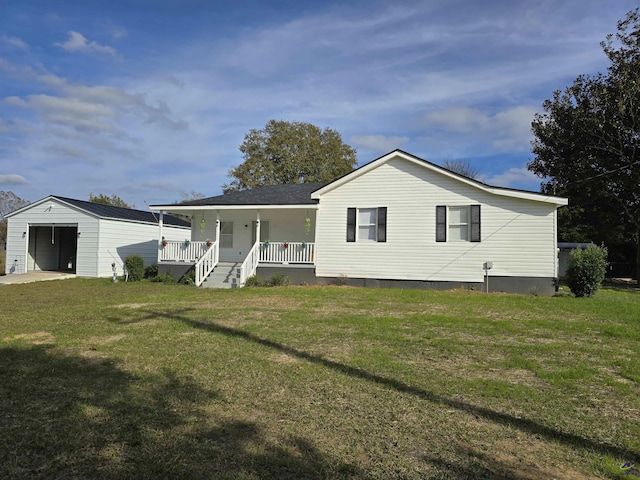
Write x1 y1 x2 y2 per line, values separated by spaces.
0 279 640 479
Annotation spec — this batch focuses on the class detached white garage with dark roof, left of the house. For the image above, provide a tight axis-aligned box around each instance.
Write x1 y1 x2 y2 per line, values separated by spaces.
6 196 190 277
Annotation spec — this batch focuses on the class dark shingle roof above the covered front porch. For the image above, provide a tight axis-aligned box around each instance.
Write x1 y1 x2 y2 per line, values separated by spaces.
178 183 327 207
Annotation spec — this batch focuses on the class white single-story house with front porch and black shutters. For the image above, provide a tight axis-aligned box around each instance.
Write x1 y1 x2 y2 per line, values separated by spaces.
151 150 567 294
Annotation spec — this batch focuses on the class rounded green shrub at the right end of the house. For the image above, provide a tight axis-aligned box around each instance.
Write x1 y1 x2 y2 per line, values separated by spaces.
566 245 607 297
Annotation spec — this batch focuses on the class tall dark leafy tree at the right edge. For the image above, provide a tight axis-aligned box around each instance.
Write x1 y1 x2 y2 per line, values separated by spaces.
527 9 640 280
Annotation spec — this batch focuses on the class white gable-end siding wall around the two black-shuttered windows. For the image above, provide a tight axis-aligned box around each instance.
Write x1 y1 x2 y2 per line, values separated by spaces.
316 157 557 282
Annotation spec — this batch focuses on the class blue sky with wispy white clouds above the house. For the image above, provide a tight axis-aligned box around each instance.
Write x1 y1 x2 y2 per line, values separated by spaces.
0 0 637 209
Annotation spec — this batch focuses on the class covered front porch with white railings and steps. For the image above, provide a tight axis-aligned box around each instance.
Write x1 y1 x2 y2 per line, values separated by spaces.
158 205 316 286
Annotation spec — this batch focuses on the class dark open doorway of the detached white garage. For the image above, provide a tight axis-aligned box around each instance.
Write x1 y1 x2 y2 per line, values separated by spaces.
27 225 78 273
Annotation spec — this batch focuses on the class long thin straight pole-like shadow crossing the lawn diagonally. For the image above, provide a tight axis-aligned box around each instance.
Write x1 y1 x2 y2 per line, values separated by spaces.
126 310 640 468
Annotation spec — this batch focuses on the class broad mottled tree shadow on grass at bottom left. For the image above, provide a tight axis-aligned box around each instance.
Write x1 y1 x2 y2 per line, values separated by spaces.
0 346 362 479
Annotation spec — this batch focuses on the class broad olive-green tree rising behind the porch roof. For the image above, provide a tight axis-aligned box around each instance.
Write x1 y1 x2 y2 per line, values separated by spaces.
222 120 357 193
